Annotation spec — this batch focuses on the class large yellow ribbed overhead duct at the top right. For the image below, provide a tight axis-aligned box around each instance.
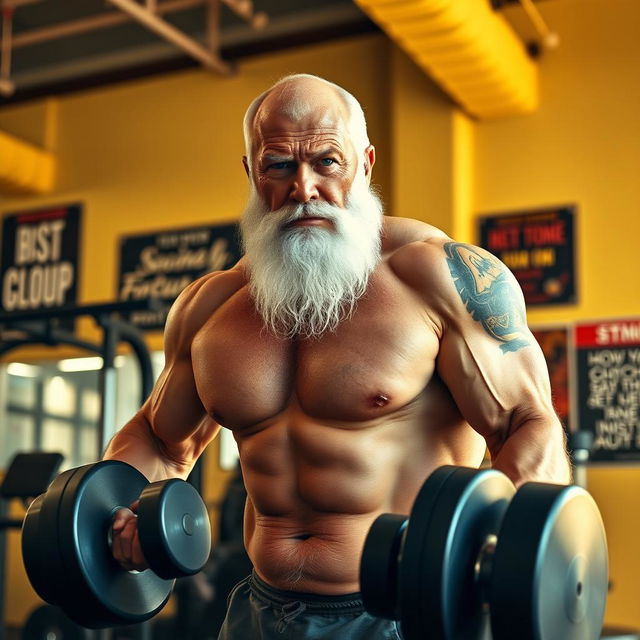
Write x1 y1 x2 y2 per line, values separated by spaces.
355 0 538 118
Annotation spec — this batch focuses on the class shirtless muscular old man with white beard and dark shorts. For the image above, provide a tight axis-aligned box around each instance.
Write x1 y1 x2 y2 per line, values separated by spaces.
105 75 570 640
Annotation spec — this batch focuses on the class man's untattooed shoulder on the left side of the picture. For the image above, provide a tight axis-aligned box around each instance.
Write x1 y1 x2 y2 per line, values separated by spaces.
165 260 247 350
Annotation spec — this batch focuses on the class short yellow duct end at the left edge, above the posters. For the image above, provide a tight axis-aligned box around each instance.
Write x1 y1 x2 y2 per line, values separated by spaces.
0 131 55 195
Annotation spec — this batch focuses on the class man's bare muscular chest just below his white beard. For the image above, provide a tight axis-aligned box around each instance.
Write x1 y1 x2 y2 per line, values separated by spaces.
192 284 438 430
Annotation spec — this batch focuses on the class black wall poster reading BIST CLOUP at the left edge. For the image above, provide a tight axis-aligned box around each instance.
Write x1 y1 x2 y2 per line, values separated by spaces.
1 204 82 320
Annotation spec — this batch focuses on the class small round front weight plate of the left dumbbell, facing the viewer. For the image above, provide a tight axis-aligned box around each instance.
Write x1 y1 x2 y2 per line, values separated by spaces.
137 479 211 578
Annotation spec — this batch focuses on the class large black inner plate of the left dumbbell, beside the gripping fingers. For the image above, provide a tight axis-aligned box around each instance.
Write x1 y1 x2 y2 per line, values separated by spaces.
58 460 173 628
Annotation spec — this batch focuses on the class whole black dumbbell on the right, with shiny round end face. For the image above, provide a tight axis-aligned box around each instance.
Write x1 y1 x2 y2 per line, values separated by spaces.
360 466 608 640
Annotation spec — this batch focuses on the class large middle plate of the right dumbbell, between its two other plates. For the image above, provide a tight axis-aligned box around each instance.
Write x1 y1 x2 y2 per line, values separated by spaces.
400 466 515 640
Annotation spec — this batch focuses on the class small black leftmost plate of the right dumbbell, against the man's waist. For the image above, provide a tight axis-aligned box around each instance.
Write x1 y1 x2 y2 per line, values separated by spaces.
360 513 408 620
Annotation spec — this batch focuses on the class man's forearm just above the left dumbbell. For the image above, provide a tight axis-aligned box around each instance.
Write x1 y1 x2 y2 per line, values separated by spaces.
103 413 191 482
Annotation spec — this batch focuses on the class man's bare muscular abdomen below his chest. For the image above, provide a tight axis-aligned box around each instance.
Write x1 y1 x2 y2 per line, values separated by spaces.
236 401 484 595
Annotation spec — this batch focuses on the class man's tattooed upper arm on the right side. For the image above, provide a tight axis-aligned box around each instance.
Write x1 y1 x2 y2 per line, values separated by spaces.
438 242 552 443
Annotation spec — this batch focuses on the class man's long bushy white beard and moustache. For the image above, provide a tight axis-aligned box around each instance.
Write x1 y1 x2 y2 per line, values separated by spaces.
241 176 382 338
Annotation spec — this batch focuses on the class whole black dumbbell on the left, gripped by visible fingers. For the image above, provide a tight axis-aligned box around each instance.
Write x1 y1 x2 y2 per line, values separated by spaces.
22 460 211 629
